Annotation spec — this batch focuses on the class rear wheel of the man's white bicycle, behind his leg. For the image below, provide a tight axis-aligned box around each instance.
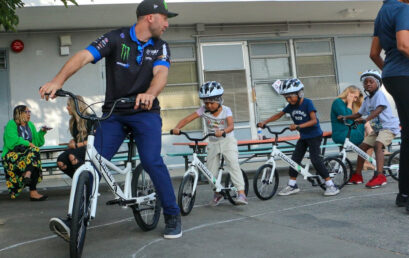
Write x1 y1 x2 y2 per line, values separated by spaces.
131 164 161 231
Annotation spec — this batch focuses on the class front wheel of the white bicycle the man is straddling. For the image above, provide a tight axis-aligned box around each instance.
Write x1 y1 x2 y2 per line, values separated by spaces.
70 171 91 257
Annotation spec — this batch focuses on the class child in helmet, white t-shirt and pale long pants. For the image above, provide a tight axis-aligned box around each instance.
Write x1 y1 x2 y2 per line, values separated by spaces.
173 81 247 206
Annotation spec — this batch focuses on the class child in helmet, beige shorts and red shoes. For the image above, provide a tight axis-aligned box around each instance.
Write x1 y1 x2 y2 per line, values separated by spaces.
338 70 400 188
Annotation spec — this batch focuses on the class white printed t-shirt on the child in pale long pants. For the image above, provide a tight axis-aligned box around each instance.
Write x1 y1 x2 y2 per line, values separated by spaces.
196 105 234 141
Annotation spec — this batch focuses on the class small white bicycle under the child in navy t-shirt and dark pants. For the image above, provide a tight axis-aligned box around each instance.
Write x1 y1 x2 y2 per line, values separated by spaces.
253 125 347 200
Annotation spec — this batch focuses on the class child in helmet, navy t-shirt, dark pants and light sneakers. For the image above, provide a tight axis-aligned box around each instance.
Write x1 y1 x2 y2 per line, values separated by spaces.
258 78 340 196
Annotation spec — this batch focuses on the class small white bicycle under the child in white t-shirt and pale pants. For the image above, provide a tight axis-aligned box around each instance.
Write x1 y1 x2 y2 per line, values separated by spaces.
170 130 249 216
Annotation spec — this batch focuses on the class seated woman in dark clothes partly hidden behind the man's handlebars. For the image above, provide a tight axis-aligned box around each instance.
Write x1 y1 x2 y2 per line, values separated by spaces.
57 96 91 178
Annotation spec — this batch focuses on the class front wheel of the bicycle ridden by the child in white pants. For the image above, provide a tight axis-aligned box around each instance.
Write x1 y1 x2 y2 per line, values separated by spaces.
178 174 196 216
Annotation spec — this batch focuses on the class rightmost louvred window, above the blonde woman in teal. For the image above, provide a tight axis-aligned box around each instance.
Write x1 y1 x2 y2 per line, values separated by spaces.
294 39 338 121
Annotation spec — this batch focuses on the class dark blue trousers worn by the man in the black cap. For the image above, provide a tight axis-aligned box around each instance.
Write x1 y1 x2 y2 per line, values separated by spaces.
94 112 180 215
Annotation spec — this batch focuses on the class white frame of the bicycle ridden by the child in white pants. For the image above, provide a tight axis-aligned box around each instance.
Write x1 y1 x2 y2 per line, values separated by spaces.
184 153 237 196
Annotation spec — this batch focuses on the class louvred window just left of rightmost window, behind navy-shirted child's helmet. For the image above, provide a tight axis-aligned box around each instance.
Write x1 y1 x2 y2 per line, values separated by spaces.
249 42 291 124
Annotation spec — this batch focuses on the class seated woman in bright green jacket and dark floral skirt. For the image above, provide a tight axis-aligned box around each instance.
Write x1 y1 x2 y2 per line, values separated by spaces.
2 105 50 201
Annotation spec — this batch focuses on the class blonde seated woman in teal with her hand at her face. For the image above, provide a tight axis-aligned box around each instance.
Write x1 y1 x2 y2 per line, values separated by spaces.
331 85 365 145
